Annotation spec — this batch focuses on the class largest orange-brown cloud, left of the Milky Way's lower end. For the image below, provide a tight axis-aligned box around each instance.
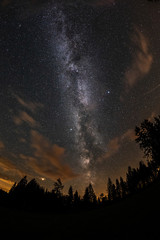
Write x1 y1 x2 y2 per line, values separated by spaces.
29 130 77 180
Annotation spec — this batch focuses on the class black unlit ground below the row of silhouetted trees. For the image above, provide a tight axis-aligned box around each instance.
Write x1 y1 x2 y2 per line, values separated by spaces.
0 183 160 240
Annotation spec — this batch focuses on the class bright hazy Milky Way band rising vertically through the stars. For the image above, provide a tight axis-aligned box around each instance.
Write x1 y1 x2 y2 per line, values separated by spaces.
50 4 103 181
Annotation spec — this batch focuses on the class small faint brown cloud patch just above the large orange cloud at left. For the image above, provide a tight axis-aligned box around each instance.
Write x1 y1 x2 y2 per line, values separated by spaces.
13 111 39 127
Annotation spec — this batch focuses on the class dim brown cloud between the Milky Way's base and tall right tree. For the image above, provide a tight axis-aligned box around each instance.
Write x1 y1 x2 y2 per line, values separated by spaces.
99 129 136 161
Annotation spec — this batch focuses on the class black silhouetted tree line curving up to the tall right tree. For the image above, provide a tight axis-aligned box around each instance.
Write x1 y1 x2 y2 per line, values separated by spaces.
0 116 160 211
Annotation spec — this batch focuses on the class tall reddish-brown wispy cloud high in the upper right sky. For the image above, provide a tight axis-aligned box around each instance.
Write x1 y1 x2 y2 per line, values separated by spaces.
125 29 153 91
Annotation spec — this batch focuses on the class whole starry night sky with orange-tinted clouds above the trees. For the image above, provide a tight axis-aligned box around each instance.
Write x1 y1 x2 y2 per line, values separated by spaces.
0 0 160 194
